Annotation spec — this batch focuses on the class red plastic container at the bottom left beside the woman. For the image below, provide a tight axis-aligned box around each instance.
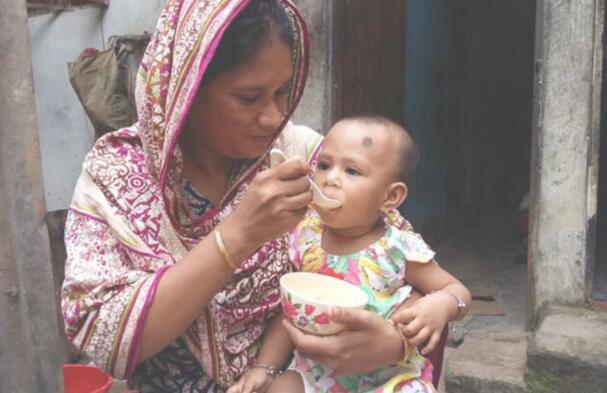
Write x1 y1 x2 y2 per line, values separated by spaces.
63 364 112 393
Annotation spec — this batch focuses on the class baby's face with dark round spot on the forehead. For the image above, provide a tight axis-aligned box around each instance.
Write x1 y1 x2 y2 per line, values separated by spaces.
314 121 398 229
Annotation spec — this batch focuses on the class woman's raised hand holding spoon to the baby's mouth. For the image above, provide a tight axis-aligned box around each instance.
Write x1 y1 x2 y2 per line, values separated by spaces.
221 157 312 254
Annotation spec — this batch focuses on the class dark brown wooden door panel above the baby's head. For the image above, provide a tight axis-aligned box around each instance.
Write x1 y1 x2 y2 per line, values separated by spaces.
332 0 406 121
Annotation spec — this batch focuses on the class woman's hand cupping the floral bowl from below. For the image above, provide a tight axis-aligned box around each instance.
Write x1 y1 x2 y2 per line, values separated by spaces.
283 307 403 375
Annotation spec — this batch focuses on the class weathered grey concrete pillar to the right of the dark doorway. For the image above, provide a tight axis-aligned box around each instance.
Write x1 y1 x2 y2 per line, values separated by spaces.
529 0 604 325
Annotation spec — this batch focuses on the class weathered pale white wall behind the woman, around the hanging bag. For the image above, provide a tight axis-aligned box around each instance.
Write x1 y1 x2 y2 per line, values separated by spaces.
29 0 163 211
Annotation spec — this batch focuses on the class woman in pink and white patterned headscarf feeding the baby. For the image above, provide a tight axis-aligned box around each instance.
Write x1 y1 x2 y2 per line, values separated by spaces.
63 0 442 392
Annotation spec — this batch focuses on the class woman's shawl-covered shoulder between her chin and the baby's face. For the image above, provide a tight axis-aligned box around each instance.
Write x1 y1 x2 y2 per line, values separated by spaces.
276 122 324 161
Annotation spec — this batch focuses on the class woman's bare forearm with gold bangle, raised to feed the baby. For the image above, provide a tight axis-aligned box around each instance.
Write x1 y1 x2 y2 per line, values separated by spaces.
139 219 257 361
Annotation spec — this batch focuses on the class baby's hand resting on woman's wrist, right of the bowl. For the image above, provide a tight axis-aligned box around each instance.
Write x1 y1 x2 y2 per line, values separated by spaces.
391 292 453 355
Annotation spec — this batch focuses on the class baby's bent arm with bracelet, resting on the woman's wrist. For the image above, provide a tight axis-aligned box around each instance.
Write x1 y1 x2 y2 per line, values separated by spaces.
392 261 470 355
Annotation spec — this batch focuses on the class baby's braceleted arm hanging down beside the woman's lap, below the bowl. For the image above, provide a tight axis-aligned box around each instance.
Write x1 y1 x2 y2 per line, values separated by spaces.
226 313 293 393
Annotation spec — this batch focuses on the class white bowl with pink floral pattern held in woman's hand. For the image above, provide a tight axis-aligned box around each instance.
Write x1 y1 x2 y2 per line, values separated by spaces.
280 272 369 336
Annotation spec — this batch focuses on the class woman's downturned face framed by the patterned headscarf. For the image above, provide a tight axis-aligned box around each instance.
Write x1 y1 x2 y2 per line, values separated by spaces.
182 35 293 159
